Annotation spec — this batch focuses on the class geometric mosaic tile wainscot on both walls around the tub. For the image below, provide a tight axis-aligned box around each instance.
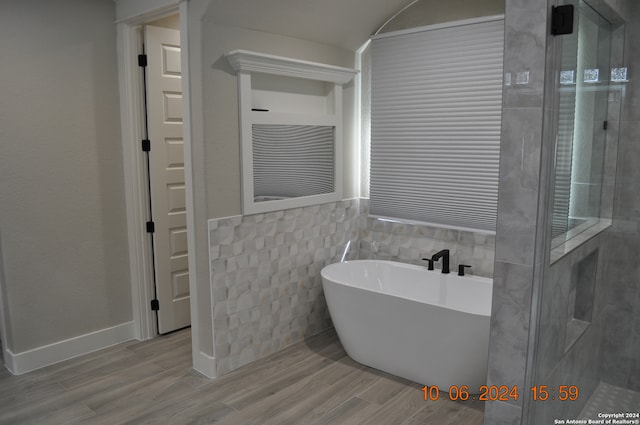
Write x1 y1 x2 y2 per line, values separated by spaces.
209 199 495 376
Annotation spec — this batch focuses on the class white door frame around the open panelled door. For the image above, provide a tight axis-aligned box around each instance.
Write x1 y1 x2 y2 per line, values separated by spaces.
116 0 198 342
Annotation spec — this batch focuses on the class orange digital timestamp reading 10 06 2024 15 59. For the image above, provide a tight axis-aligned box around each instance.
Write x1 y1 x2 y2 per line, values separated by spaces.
422 385 580 401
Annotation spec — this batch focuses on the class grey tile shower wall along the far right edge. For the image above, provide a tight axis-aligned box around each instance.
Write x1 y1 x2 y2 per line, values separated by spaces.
602 0 640 391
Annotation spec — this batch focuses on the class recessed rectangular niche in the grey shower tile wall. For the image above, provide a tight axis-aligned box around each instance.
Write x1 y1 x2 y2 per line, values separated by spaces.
565 250 598 351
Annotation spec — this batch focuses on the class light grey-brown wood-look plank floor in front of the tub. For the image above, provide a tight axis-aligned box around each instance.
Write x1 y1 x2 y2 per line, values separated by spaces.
0 330 483 425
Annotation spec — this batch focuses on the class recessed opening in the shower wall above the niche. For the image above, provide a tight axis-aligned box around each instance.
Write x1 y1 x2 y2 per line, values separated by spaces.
552 0 611 247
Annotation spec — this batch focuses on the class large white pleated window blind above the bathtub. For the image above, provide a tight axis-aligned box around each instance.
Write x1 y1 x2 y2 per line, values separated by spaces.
370 17 504 231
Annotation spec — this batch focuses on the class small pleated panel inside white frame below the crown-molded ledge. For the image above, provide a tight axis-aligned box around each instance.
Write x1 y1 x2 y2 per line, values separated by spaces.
252 124 335 202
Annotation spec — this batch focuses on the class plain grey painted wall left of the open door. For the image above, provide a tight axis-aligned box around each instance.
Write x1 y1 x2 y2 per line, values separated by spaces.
0 0 132 353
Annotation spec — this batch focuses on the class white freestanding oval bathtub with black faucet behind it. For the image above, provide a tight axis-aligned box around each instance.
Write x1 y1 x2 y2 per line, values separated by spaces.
322 260 493 394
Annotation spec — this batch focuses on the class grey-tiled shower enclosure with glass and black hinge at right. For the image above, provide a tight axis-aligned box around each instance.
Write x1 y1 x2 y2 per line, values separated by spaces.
522 0 640 424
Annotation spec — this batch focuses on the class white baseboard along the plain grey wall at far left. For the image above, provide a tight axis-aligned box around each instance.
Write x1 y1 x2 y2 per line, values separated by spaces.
4 322 135 375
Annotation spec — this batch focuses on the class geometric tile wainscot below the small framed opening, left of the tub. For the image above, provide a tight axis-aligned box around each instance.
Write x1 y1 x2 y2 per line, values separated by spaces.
209 200 360 376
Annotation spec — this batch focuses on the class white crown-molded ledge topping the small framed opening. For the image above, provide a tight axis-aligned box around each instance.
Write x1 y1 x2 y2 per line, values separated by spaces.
225 50 358 84
